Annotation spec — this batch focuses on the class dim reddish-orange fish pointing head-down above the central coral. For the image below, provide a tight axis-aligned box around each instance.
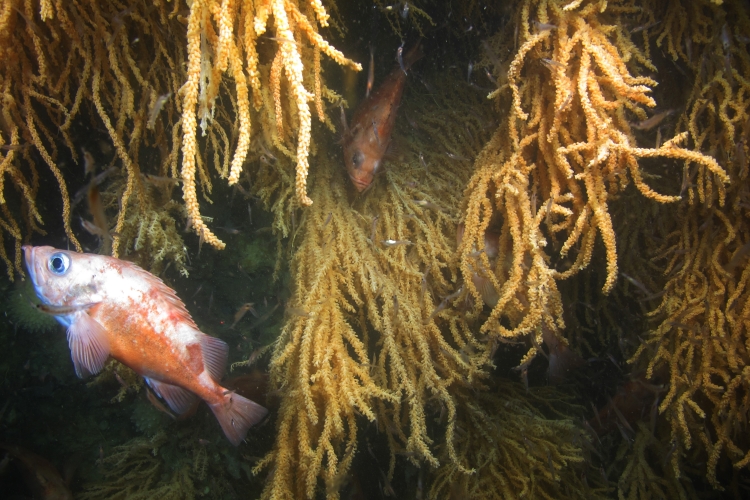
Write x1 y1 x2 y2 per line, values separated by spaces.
343 43 422 193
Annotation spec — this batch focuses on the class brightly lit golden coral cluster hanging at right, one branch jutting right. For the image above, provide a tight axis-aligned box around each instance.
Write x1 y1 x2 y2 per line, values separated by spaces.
459 0 728 372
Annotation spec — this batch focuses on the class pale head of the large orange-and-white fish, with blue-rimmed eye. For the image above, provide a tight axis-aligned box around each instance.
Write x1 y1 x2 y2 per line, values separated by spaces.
23 246 104 305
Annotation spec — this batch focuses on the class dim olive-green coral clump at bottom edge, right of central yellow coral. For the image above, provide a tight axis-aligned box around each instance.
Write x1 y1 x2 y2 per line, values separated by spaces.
428 379 608 500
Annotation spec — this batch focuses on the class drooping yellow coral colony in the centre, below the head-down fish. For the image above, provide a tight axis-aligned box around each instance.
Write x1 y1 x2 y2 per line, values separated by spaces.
256 80 500 498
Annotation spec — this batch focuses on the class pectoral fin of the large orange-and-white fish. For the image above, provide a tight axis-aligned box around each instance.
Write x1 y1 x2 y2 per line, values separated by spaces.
68 311 109 378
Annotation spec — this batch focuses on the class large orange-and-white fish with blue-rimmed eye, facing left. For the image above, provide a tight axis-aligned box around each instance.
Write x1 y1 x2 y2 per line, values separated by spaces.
23 246 268 445
